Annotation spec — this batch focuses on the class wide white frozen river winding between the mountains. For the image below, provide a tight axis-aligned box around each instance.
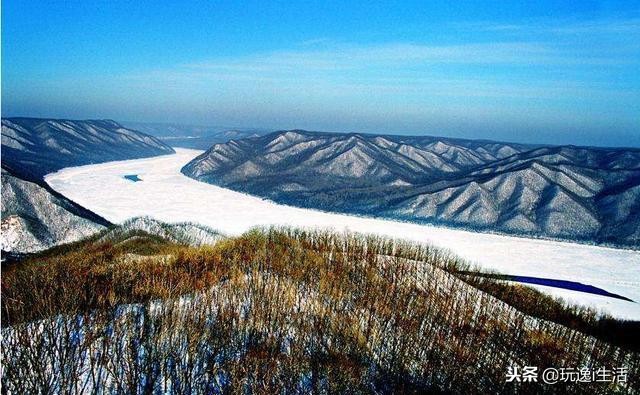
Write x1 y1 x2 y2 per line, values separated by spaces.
45 148 640 320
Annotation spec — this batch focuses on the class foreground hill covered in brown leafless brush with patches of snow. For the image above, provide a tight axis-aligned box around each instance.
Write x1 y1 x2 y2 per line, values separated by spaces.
2 229 640 393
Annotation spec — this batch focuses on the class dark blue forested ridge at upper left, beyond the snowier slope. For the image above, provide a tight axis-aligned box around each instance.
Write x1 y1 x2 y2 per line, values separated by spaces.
2 118 174 182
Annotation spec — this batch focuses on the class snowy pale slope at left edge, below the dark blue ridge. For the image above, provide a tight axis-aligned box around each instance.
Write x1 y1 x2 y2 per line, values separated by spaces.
0 168 109 253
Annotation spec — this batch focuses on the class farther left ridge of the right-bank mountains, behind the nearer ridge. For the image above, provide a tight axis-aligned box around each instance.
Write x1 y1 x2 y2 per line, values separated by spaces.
183 130 530 191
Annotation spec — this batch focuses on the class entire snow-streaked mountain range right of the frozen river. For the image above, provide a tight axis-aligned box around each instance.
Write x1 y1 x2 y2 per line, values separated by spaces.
182 130 640 246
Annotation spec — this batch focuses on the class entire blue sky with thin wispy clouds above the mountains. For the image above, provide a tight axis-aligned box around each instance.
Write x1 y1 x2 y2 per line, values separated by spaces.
2 0 640 146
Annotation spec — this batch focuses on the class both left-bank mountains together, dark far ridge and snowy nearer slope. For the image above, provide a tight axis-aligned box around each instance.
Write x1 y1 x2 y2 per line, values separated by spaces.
1 118 174 253
